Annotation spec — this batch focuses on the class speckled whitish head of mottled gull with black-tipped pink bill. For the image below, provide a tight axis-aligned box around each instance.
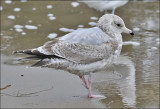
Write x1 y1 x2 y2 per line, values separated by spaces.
97 14 134 35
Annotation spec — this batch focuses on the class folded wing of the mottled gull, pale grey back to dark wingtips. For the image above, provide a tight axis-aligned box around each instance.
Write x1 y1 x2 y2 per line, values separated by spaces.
16 27 118 64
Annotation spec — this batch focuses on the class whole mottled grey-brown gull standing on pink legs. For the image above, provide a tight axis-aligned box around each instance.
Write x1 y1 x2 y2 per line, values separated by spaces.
14 14 134 98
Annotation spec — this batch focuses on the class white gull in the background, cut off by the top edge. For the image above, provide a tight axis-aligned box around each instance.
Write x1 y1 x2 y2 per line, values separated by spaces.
79 0 128 14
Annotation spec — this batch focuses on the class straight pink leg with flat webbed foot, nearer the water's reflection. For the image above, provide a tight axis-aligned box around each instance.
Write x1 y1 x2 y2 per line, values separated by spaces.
88 73 105 98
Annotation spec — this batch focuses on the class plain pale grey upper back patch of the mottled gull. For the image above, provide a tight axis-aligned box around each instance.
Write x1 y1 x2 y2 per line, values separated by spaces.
59 27 111 45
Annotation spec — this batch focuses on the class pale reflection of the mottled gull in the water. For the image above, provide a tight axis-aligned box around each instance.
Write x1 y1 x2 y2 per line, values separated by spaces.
95 56 136 108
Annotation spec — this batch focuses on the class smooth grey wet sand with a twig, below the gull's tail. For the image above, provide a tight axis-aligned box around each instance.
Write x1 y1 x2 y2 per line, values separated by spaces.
1 56 104 108
